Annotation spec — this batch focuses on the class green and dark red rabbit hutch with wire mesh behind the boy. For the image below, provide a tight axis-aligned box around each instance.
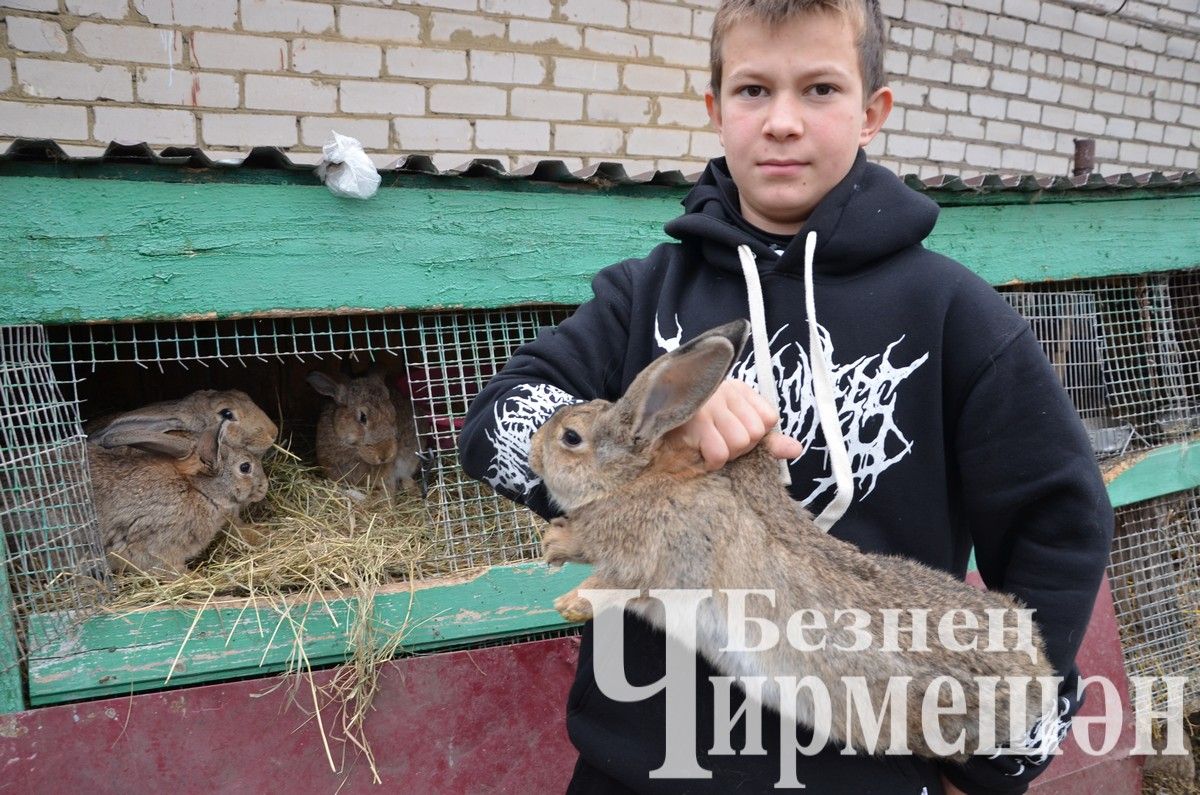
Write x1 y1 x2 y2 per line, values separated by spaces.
0 141 1200 793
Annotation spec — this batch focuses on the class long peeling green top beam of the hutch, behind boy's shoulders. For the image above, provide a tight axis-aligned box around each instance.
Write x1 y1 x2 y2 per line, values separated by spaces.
0 177 1200 323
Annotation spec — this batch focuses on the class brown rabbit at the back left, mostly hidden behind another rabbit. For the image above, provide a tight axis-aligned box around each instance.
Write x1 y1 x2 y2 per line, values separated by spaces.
86 389 280 467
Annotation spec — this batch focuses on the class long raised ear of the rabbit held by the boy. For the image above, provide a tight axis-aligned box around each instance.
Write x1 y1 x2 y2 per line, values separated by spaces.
617 321 749 446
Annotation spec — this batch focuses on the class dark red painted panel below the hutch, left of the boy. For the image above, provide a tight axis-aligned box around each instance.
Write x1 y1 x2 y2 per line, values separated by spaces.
0 638 578 795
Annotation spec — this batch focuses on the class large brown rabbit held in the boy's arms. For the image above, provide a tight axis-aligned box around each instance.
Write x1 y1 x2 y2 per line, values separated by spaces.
529 321 1052 761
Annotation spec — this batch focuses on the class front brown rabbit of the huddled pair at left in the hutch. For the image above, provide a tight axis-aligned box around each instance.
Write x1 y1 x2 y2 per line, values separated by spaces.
88 420 268 576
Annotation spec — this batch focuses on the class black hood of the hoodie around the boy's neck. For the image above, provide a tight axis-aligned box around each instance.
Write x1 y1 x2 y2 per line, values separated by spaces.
664 149 938 275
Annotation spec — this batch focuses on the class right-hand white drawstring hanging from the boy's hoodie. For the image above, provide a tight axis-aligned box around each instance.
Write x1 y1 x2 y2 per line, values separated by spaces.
804 232 854 532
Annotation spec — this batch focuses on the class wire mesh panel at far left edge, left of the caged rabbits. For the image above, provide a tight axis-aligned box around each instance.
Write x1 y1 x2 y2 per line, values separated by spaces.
0 325 108 651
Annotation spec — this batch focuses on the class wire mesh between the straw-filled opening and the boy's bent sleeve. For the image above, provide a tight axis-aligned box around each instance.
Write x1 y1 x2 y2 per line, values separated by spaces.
404 307 571 569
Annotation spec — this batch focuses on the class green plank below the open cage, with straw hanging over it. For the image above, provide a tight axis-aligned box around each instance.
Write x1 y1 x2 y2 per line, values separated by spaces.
29 563 589 706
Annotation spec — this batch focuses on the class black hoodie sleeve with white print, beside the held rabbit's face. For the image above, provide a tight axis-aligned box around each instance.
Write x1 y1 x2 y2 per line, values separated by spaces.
458 262 631 519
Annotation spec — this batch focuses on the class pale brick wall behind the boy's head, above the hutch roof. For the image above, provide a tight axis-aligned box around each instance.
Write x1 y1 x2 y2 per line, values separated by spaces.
0 0 1200 177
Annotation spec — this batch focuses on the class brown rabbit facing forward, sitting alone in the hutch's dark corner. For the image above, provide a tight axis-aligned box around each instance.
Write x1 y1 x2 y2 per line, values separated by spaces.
307 372 421 495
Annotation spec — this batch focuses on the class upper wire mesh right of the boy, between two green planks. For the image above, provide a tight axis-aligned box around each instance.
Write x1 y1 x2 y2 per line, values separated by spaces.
1001 271 1200 460
